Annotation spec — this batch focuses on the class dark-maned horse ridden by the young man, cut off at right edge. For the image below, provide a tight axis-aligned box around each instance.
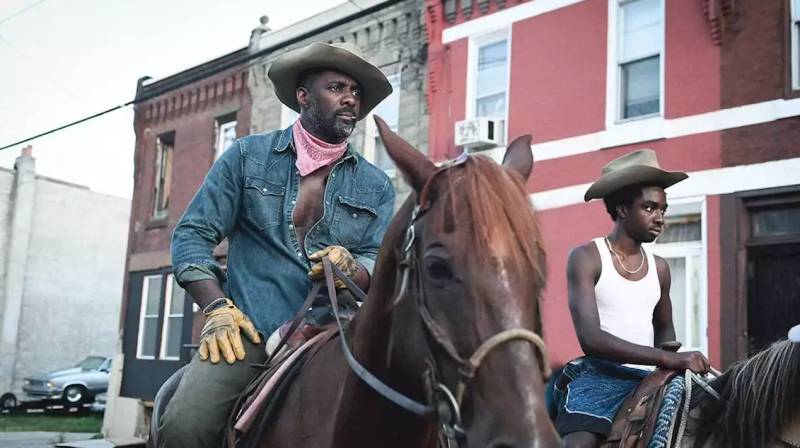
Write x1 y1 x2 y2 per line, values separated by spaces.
673 340 800 448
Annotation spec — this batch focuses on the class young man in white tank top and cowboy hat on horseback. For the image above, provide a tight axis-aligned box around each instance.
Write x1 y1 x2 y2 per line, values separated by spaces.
554 149 709 447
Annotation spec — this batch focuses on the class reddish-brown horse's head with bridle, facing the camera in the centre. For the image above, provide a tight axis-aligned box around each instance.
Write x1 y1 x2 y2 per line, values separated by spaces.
365 118 558 448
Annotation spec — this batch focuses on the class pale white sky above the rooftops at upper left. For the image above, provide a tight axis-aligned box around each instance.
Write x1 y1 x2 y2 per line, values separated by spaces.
0 0 344 198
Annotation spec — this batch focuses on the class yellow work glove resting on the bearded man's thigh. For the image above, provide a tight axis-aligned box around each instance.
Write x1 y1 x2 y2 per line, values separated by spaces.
198 299 261 364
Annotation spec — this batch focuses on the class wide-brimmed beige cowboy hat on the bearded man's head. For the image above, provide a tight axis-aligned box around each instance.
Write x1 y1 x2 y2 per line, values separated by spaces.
267 42 392 120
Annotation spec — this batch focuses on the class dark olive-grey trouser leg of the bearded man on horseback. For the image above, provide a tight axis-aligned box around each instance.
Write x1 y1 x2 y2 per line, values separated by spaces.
154 335 267 448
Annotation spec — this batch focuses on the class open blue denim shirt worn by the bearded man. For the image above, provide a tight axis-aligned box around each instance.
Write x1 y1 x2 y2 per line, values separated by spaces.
171 127 394 334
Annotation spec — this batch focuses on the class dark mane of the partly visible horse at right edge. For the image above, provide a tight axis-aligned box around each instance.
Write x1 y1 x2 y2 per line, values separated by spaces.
698 340 800 448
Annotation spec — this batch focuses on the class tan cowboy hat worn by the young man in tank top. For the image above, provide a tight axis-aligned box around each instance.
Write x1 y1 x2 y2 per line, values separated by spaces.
583 149 689 201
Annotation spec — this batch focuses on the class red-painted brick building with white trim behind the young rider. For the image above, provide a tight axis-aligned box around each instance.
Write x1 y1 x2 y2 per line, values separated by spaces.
425 0 800 366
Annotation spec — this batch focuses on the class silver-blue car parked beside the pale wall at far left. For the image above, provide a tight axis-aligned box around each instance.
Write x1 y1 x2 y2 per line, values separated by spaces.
22 356 111 404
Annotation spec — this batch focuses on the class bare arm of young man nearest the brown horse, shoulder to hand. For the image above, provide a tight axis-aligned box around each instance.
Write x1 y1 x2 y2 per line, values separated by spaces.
567 243 708 369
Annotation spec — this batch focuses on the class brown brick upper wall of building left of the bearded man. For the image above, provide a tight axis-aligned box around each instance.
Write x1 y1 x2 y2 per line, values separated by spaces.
128 68 250 264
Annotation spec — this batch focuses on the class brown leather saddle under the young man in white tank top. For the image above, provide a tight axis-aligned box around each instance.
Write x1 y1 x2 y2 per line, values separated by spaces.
601 369 681 448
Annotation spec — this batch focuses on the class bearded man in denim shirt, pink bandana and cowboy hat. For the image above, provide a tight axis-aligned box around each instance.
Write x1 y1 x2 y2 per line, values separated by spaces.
159 43 394 447
